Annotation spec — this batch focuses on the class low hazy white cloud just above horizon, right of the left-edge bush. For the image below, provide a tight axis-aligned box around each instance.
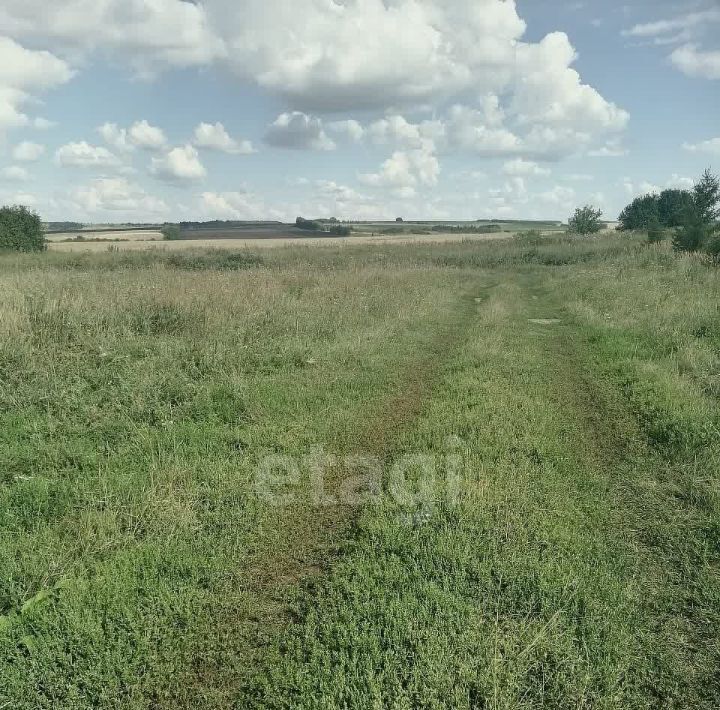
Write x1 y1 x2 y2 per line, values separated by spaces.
69 178 168 221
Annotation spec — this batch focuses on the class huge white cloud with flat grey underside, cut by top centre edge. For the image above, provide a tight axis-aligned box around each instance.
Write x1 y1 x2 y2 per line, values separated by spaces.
207 0 525 111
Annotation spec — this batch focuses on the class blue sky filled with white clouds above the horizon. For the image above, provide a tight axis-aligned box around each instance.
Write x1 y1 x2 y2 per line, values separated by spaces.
0 0 720 223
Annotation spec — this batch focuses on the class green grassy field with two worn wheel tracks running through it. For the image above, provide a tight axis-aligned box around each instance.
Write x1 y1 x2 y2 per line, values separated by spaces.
0 235 720 710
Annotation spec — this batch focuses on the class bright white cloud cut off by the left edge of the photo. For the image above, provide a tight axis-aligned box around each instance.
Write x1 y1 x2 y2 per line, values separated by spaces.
0 37 72 135
